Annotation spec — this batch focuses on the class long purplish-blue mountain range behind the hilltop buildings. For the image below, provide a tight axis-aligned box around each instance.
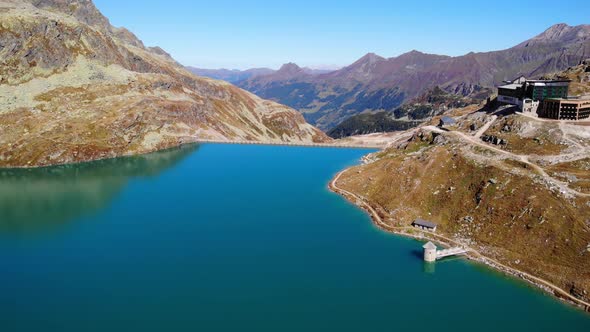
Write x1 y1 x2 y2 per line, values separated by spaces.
237 24 590 129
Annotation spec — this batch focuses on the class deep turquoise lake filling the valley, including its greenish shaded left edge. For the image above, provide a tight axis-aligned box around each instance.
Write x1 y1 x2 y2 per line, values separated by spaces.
0 144 590 332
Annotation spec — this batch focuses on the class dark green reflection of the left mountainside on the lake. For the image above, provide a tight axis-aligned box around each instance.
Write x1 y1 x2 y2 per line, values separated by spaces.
0 144 198 235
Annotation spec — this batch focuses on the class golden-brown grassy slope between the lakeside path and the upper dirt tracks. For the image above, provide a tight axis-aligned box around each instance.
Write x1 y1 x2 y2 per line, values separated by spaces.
338 123 590 300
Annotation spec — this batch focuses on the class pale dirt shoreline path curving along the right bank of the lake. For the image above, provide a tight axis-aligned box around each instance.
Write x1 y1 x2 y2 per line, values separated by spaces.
328 168 590 313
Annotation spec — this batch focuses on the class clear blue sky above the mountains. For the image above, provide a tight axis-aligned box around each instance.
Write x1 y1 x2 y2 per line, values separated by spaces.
94 0 590 69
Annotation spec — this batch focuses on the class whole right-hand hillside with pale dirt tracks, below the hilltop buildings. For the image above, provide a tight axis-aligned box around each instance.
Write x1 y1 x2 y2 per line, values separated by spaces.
336 107 590 302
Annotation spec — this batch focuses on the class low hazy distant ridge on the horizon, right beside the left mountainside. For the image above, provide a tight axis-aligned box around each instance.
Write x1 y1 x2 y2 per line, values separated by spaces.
186 63 332 83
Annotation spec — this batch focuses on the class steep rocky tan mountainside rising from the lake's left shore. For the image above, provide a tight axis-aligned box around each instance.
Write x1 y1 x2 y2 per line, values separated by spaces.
0 0 328 167
